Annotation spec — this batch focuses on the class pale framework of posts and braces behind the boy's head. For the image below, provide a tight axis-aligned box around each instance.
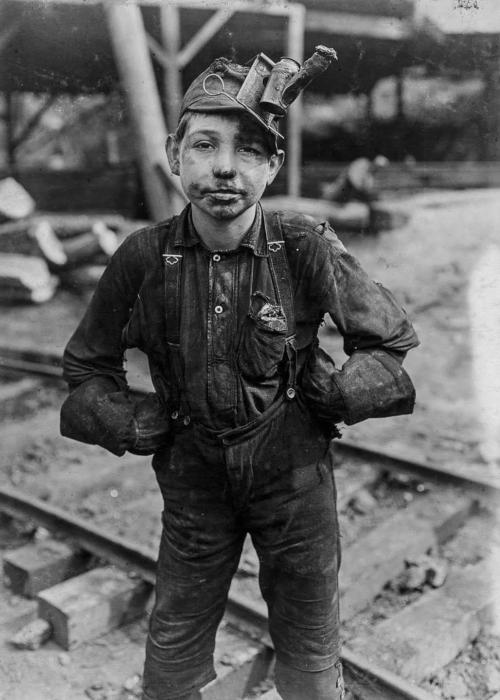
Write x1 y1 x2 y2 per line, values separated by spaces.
0 0 306 208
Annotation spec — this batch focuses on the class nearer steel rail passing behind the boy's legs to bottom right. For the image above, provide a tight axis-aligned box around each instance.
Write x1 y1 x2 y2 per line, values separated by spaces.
0 487 432 700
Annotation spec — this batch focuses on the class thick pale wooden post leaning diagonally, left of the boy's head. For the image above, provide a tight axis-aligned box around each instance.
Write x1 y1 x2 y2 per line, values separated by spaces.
103 3 186 220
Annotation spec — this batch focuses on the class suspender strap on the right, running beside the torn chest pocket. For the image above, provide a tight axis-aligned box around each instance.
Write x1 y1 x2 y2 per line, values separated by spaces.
264 212 297 399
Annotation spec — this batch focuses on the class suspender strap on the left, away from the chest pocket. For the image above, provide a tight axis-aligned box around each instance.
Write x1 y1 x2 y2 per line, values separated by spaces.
163 226 190 425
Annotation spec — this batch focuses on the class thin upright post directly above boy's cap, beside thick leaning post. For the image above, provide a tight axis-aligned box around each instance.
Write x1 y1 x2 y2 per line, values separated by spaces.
160 4 182 131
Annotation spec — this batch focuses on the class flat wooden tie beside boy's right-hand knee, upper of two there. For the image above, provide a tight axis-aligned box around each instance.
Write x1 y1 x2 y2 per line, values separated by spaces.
339 494 474 620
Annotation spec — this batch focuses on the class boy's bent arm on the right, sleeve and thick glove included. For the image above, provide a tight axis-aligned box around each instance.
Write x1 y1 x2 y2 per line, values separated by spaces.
303 224 419 425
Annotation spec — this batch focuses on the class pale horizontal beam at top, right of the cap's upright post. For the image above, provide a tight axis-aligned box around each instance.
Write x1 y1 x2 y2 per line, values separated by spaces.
305 10 411 41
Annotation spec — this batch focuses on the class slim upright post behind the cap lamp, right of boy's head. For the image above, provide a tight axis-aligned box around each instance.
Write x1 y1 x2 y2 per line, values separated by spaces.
286 5 305 197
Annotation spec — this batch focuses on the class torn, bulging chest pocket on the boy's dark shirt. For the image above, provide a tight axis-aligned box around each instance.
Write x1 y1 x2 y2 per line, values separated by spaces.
238 292 288 380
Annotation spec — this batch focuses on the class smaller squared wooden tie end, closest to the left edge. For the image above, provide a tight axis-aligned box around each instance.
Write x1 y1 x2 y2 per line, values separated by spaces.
3 540 90 598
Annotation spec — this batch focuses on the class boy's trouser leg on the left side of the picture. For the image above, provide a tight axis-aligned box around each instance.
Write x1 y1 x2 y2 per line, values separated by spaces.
143 431 244 700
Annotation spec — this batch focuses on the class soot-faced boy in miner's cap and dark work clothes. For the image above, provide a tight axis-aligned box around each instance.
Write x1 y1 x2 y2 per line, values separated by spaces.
61 49 417 700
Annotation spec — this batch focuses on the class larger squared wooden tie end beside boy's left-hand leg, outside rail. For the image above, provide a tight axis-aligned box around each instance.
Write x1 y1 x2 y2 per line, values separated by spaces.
38 566 152 649
